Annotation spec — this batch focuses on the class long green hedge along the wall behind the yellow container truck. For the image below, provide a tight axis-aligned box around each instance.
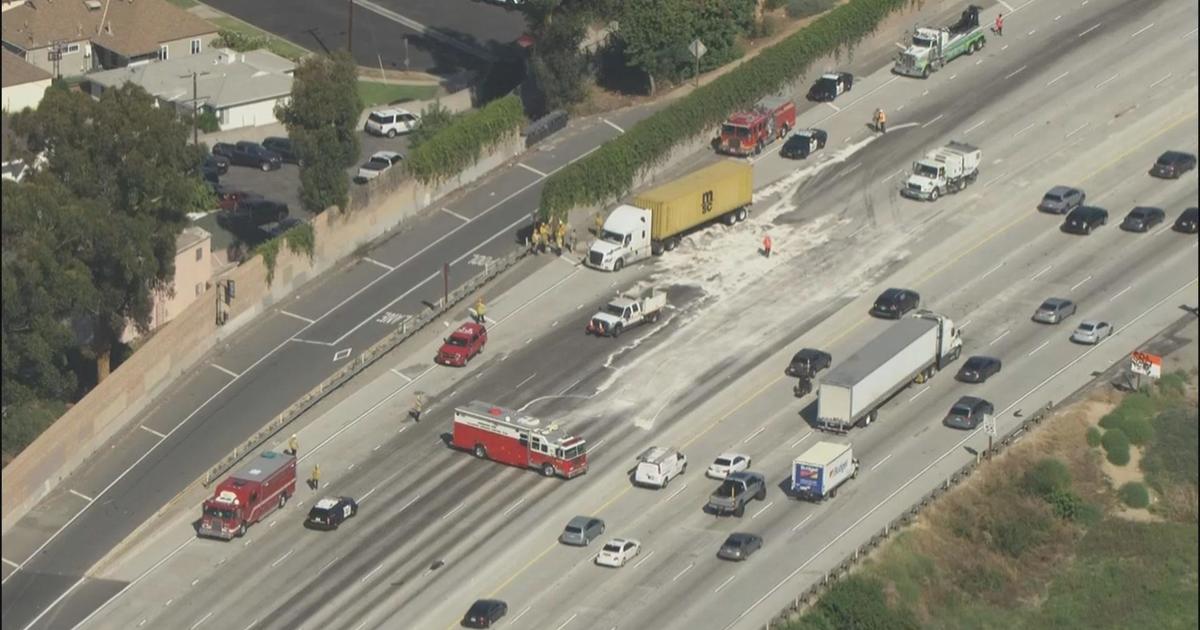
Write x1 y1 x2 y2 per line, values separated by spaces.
540 0 911 218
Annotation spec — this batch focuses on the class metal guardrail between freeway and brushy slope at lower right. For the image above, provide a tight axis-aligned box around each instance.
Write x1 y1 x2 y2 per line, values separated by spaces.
766 402 1054 630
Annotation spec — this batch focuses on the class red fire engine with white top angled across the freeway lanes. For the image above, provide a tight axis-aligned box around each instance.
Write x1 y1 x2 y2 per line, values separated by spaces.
451 401 588 479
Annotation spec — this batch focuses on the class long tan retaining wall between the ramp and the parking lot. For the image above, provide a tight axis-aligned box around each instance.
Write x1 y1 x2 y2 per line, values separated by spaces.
0 132 523 532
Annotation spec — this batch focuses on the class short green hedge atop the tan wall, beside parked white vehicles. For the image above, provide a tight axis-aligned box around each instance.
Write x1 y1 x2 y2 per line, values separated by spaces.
406 95 524 184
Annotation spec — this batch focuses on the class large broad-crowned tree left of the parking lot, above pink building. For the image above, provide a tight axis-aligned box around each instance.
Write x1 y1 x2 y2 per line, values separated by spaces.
13 84 211 380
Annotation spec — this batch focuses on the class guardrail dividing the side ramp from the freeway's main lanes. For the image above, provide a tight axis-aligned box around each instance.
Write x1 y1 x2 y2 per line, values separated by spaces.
200 247 528 487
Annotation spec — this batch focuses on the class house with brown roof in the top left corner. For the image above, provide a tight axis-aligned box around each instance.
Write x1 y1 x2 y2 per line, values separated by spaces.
0 0 217 77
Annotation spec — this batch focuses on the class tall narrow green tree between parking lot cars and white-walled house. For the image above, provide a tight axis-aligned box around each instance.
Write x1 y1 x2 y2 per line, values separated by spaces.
275 50 362 212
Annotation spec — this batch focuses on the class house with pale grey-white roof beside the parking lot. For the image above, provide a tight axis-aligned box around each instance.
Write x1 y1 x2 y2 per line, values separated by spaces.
88 49 295 130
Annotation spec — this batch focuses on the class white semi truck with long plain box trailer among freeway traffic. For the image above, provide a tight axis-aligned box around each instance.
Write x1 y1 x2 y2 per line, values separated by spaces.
816 311 962 433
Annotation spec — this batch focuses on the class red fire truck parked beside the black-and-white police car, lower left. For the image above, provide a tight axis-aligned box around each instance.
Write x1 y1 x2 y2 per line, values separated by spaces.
197 451 296 540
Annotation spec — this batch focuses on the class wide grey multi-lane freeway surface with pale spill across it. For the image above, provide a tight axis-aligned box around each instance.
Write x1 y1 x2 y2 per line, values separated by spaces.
5 0 1198 629
